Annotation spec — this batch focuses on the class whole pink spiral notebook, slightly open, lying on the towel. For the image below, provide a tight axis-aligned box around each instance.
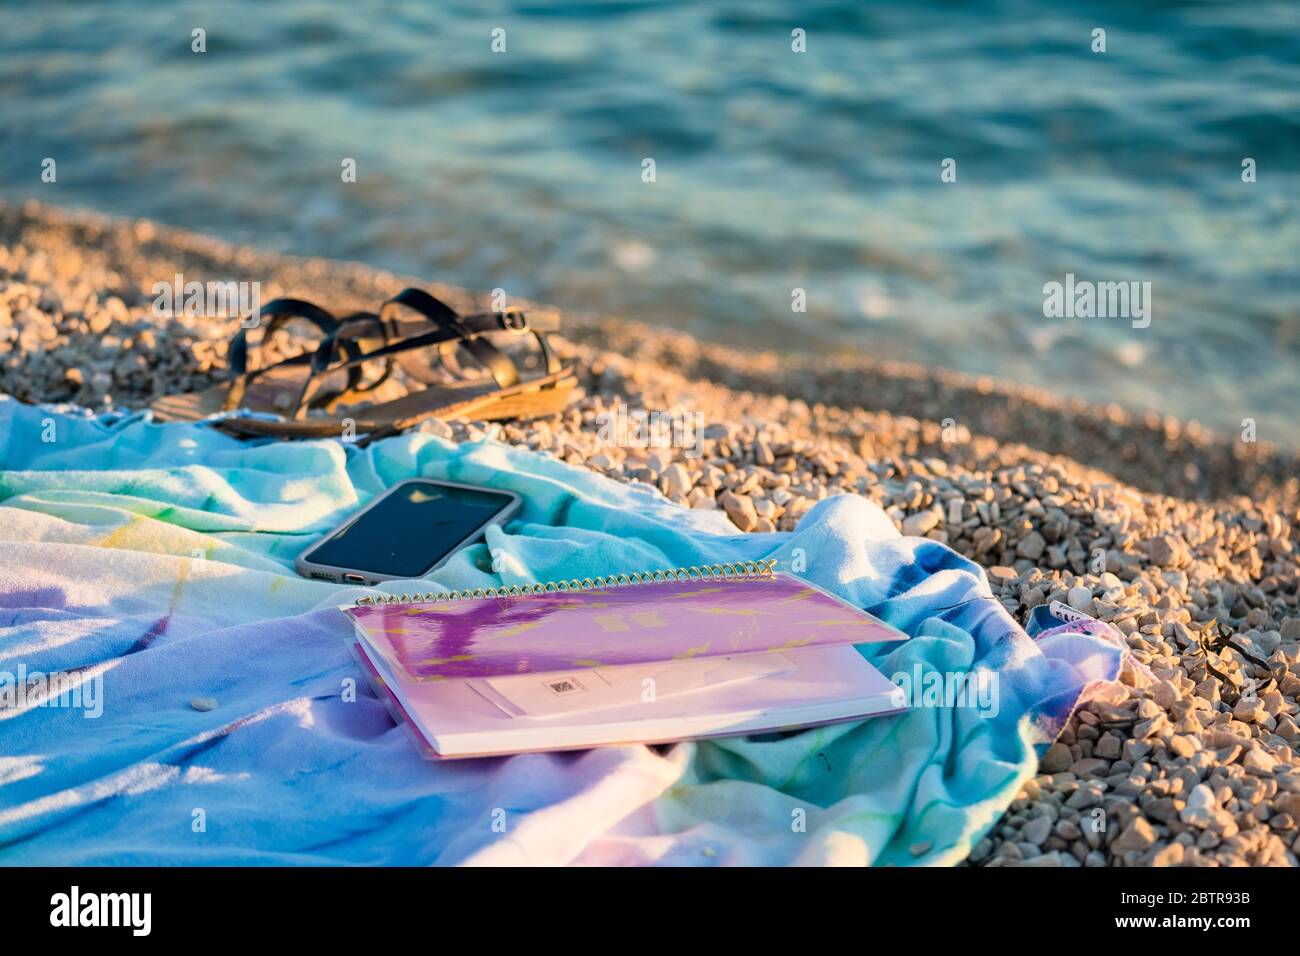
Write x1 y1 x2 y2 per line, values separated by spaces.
345 562 906 758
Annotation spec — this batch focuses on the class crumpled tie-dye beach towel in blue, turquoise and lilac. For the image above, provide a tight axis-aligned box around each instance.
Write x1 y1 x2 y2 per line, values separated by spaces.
0 398 1123 865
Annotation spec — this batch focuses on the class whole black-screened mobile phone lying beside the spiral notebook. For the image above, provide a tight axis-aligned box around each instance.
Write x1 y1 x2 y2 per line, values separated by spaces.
306 481 511 578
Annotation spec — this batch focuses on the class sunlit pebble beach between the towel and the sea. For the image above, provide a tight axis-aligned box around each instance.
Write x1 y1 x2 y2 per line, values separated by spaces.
0 203 1300 866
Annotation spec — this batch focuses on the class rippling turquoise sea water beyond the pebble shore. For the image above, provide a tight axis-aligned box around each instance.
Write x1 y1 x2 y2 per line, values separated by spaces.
0 0 1300 445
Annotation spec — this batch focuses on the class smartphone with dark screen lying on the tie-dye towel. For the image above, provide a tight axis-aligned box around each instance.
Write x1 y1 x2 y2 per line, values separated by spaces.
295 479 523 584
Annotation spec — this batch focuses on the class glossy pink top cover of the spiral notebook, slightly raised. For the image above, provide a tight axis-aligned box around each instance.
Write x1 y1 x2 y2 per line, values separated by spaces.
347 572 906 680
